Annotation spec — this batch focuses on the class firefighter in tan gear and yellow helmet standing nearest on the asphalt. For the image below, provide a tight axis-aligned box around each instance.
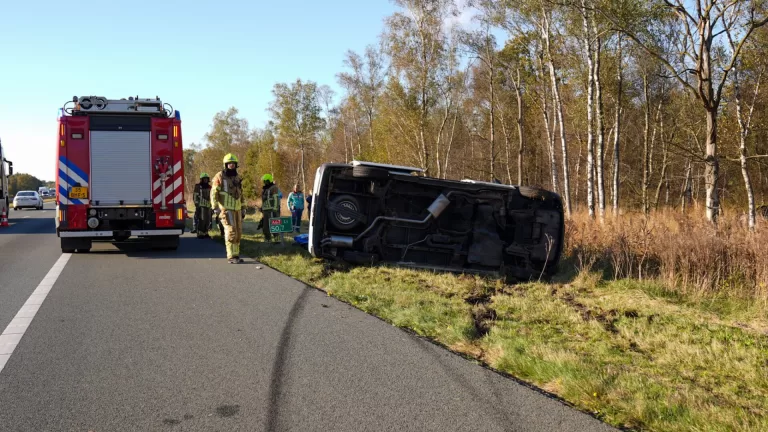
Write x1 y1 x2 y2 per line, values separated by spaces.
211 153 245 264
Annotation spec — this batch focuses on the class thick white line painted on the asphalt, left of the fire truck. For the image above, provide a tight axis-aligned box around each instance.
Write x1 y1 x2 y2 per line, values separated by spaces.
0 254 72 372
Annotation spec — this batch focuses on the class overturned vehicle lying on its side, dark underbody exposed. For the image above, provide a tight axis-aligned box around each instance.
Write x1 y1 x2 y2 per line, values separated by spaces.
309 161 564 281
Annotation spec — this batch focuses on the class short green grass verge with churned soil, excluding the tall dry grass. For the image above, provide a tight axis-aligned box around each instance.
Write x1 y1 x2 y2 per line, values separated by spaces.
195 216 768 431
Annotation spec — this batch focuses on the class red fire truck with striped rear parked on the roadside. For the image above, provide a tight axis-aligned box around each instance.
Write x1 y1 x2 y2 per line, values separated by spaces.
56 96 187 253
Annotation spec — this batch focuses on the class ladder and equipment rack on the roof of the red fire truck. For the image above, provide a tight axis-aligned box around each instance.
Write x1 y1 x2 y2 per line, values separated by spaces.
62 96 178 118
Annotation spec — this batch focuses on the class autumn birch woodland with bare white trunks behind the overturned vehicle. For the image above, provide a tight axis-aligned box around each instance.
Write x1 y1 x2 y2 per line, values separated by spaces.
187 0 768 230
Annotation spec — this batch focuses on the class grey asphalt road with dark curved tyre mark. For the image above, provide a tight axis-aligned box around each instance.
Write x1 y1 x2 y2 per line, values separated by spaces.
0 205 611 432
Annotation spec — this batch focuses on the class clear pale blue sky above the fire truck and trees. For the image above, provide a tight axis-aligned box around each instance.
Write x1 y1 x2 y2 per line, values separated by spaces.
0 0 395 180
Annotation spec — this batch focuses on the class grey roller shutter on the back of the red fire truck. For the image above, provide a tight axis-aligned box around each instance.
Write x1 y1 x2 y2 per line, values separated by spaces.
91 128 152 206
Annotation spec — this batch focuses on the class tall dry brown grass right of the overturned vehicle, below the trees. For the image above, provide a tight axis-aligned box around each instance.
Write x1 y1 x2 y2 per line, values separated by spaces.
566 211 768 310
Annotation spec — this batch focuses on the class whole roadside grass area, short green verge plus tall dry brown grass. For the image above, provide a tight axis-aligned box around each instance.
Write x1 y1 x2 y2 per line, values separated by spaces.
194 208 768 431
